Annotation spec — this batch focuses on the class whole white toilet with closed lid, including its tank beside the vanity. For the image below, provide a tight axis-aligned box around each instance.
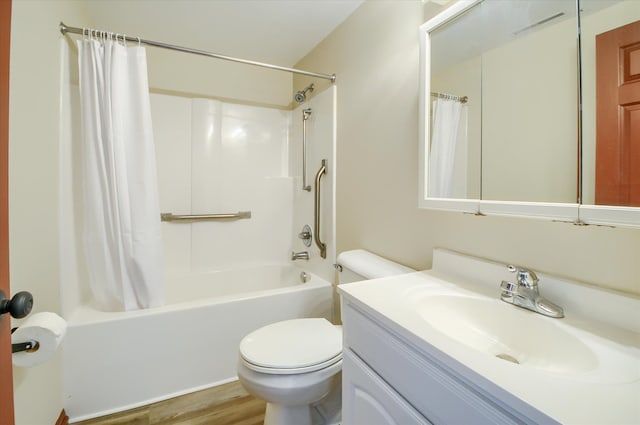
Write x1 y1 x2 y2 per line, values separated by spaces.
238 249 414 425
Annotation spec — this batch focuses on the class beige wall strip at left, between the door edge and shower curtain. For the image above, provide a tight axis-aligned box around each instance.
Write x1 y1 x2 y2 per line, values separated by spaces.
9 0 88 425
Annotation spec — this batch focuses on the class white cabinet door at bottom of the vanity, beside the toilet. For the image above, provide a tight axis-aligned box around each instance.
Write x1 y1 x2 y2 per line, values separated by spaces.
342 350 431 425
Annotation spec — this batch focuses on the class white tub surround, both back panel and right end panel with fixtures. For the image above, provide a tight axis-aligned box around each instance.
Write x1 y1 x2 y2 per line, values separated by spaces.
151 87 335 281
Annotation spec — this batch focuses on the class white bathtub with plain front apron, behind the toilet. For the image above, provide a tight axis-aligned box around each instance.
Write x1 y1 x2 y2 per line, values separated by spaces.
62 265 333 422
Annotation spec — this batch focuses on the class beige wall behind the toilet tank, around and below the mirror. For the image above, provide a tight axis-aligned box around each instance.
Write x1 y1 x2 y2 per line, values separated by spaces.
294 0 640 294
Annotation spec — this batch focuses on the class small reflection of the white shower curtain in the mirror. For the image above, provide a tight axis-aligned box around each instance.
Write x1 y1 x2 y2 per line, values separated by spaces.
428 98 467 198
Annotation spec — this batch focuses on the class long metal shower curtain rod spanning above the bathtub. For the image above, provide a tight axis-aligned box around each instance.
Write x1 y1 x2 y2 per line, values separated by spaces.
60 22 336 83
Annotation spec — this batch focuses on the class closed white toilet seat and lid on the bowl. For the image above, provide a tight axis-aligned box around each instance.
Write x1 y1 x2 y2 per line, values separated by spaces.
240 318 342 374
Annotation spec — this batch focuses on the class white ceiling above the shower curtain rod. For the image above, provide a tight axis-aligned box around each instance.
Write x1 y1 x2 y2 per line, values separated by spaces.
77 0 362 67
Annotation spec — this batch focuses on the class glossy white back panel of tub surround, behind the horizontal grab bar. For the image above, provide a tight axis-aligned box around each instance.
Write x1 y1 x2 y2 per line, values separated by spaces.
151 94 293 273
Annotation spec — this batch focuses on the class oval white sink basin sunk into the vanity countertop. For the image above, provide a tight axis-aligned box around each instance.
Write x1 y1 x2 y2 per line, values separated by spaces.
415 295 598 373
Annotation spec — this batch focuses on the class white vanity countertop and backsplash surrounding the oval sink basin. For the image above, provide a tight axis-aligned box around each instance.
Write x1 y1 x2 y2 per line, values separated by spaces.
339 251 640 424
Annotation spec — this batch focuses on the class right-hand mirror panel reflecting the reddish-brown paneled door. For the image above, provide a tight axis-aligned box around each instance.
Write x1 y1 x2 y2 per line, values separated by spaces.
580 0 640 207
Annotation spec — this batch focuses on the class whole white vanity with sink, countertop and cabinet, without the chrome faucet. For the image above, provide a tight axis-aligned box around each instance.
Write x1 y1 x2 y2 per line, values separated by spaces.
338 249 640 425
